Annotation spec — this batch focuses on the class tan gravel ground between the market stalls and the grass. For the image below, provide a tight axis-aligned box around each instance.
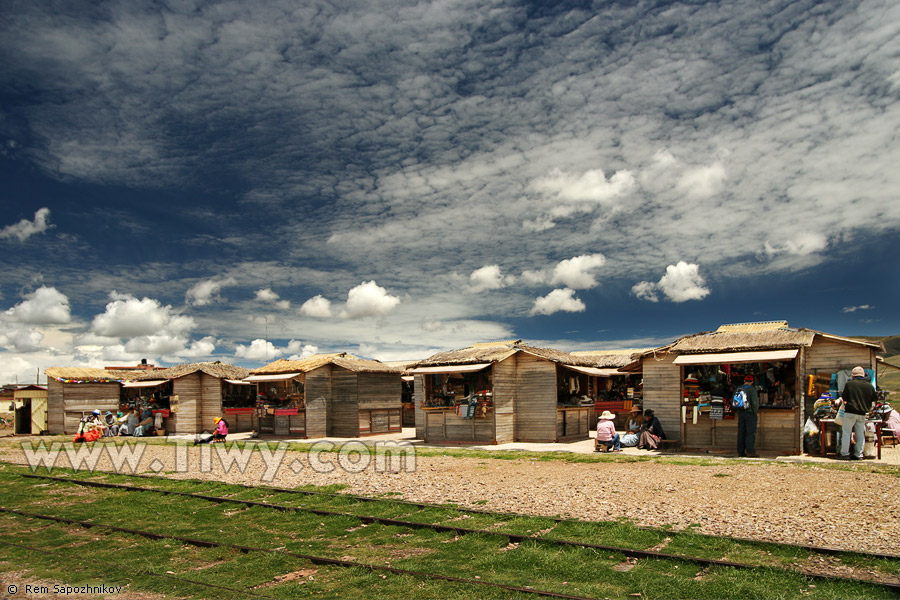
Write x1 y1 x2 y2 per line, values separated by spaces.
0 442 900 556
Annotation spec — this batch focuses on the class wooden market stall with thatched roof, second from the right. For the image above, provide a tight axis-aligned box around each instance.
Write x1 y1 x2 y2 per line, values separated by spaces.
410 340 597 444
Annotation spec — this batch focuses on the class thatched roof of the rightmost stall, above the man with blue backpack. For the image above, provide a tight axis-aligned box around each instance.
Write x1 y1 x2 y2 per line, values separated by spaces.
643 321 879 356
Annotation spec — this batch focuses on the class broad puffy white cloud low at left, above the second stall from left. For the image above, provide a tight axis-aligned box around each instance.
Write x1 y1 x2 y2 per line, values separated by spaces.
91 291 195 338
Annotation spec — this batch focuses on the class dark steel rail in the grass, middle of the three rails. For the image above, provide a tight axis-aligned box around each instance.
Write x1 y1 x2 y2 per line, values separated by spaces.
21 474 900 592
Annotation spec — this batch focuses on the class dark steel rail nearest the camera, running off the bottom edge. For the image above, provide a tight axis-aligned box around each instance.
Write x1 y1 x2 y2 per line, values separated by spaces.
0 507 599 600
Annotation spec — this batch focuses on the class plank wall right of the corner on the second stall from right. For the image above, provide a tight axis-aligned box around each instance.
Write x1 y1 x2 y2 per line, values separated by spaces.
515 352 556 442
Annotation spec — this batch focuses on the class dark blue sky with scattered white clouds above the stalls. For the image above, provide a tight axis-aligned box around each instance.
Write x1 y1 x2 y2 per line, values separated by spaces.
0 0 900 382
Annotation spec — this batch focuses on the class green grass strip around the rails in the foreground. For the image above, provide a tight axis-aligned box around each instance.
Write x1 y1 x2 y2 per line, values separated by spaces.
0 465 900 599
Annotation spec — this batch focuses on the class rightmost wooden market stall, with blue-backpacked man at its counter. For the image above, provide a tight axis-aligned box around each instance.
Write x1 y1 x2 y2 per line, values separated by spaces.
641 321 880 454
